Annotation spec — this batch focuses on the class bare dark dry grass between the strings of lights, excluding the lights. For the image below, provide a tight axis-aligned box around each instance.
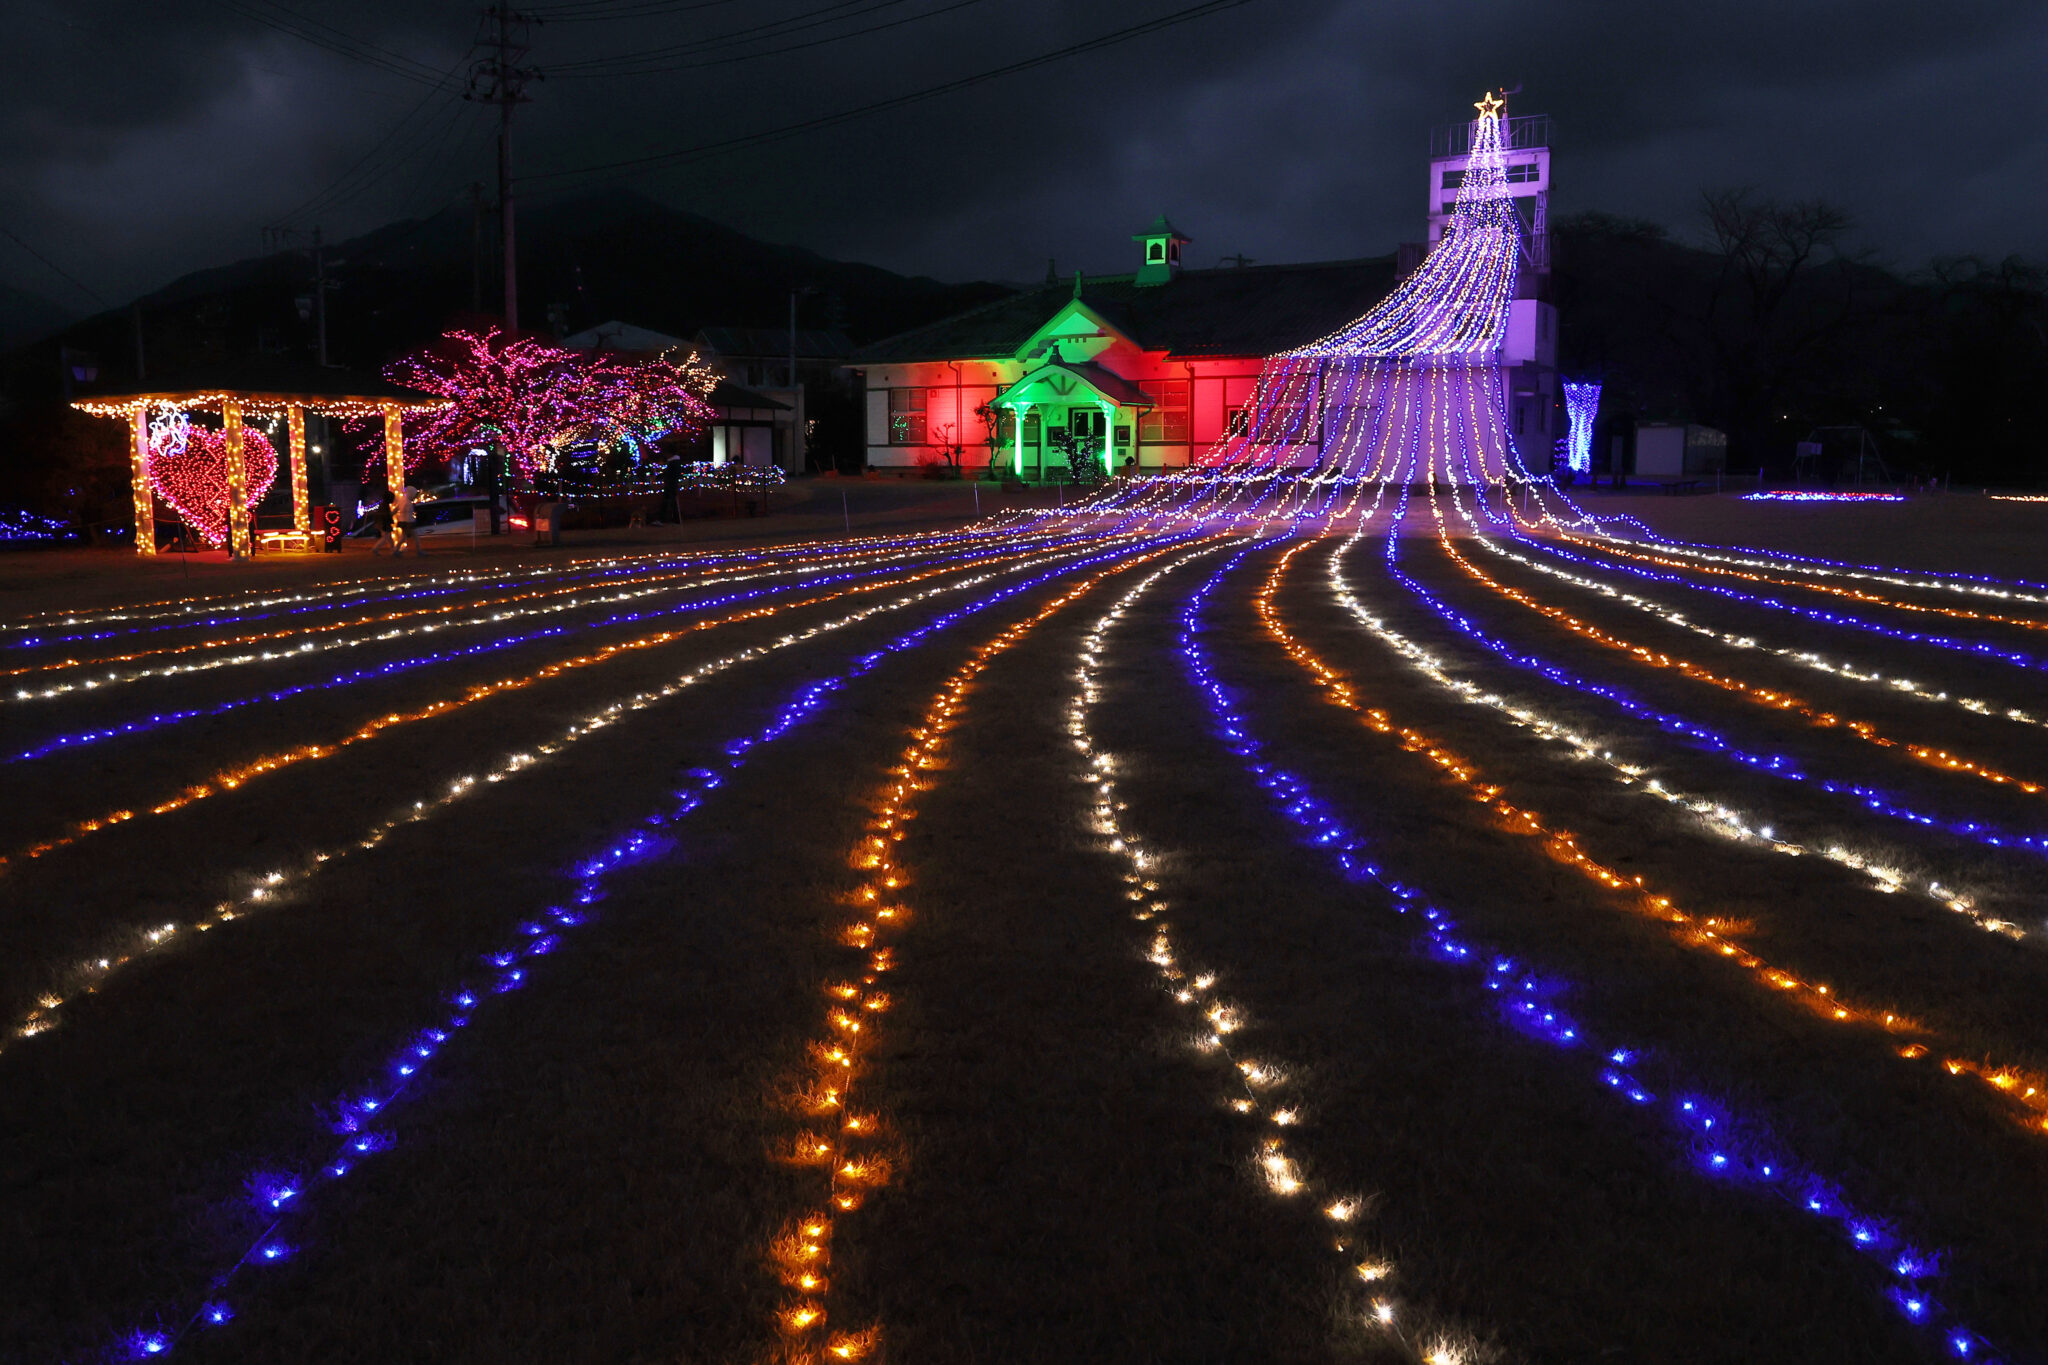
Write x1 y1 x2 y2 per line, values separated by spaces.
0 489 2048 1365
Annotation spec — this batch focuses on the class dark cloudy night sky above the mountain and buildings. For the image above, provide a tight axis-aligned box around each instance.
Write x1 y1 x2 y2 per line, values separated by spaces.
0 0 2048 311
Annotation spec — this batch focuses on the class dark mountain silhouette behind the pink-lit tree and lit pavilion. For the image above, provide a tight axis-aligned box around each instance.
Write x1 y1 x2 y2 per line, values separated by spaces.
0 188 1010 405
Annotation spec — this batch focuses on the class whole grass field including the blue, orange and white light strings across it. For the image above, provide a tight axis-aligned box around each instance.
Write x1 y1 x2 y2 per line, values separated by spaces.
0 487 2048 1365
